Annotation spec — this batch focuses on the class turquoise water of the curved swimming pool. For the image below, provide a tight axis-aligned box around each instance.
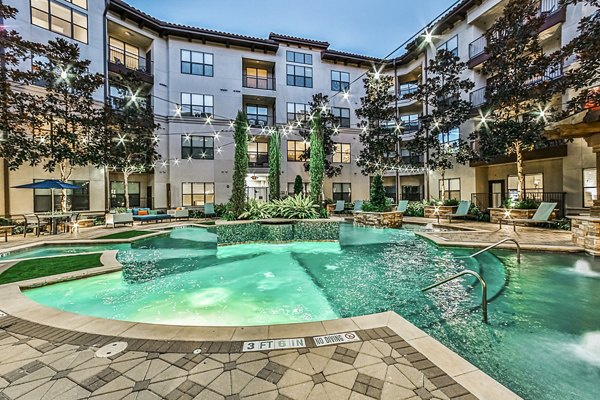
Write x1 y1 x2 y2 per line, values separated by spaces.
19 225 600 400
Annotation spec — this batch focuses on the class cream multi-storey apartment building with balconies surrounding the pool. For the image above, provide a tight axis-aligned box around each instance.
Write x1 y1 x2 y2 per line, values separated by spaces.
0 0 596 215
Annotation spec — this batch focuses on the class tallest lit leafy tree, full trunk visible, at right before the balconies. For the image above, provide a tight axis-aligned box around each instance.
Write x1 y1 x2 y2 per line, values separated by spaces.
473 0 560 199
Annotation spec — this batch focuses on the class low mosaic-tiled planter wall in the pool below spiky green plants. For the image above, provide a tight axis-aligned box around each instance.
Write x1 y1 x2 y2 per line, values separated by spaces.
215 219 340 245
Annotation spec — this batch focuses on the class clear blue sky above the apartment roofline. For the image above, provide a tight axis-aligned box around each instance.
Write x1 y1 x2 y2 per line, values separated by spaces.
125 0 455 57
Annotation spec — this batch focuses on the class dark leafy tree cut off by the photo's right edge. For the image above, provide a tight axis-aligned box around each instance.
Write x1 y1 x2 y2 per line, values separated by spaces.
560 0 600 112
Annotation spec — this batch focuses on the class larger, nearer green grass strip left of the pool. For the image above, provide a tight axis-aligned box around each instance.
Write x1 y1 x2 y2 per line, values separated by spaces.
0 254 102 285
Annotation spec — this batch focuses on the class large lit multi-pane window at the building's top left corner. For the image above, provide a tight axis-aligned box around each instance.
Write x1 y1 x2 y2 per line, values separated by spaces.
31 0 88 43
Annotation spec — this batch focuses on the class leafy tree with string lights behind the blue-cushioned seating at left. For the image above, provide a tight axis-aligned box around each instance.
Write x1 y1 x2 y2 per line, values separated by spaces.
96 73 160 208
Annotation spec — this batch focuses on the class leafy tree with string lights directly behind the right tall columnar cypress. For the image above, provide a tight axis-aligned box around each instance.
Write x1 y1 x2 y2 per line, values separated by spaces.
300 93 343 178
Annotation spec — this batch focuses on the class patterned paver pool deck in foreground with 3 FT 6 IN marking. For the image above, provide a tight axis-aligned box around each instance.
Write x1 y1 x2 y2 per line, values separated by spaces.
0 285 519 400
